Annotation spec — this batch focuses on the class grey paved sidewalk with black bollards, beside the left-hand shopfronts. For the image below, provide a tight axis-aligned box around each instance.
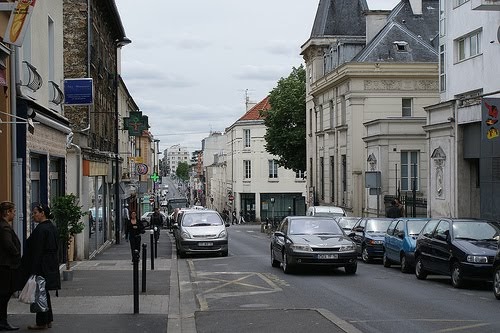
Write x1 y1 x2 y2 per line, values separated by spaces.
8 230 172 333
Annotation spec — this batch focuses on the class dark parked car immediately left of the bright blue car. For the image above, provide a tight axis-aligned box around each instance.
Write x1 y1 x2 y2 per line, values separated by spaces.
349 217 393 263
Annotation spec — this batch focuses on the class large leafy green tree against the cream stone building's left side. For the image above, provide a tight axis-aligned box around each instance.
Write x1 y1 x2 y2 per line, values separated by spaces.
262 65 306 171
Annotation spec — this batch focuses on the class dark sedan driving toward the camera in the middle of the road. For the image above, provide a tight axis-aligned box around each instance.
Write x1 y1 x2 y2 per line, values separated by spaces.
270 216 358 274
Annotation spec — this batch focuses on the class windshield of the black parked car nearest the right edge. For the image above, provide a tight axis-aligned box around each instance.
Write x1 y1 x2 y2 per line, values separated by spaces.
453 221 500 241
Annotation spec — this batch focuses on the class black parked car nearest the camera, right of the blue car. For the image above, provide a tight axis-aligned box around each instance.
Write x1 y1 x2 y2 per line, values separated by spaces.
415 218 500 288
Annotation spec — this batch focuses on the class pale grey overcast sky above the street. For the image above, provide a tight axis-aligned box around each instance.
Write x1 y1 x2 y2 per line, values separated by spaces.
116 0 399 152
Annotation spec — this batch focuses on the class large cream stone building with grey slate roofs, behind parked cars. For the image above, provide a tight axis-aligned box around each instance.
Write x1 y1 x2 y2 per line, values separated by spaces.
301 0 438 216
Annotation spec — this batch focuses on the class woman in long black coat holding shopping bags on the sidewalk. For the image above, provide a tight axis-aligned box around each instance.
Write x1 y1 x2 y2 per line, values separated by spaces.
21 204 61 330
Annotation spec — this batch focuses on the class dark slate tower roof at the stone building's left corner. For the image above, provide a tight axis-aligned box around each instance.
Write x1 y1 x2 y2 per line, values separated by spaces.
311 0 368 38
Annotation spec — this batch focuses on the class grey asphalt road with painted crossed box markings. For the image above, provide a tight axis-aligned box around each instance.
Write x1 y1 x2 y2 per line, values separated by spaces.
179 225 500 333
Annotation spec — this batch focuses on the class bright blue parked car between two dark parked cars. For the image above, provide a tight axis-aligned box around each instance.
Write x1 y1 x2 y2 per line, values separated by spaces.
382 218 430 273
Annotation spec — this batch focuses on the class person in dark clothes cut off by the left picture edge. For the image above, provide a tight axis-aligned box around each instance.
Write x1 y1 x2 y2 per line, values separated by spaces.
0 201 21 331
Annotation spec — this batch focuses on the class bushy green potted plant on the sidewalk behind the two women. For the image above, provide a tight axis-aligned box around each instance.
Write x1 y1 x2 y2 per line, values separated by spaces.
51 194 87 281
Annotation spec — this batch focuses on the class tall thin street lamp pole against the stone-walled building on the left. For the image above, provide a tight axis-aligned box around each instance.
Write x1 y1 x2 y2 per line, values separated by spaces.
114 37 132 244
